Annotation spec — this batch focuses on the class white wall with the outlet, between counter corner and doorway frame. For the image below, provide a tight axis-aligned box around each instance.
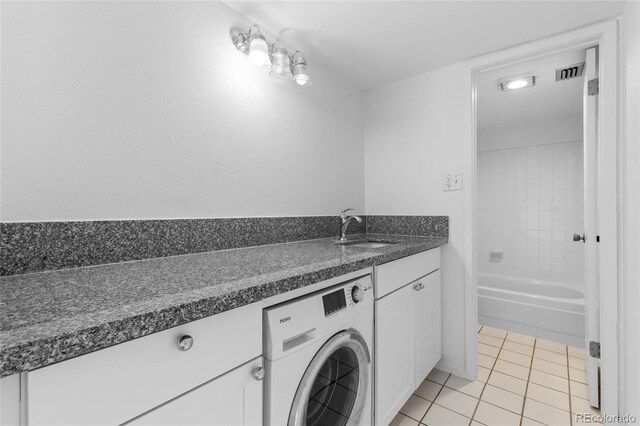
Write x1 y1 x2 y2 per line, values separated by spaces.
364 64 466 374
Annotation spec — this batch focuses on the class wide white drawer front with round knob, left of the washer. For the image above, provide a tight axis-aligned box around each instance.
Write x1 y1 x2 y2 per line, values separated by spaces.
27 304 262 425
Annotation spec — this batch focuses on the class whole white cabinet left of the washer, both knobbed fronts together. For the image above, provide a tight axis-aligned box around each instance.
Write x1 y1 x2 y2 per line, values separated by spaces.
18 304 262 426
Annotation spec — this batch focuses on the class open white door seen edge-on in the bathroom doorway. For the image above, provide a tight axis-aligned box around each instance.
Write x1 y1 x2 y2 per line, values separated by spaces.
576 47 600 407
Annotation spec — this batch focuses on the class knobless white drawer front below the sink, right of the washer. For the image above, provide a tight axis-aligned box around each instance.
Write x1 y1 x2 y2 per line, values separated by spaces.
374 247 440 299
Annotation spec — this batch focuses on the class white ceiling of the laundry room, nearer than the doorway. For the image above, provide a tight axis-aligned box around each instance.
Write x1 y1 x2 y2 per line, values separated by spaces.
226 0 625 90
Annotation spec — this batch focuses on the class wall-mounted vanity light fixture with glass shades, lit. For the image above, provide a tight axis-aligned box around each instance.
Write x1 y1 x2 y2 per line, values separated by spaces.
229 25 311 87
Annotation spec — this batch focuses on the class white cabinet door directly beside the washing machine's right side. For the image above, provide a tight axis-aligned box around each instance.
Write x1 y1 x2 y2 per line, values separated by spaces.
374 285 416 426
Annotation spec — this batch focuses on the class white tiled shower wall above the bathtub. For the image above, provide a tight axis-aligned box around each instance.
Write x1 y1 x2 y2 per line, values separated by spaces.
478 142 584 285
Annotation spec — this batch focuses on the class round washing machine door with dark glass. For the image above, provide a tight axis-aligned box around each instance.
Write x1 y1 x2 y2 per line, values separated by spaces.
289 330 371 426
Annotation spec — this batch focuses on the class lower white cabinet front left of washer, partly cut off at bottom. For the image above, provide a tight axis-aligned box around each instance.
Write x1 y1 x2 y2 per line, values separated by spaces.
125 358 262 426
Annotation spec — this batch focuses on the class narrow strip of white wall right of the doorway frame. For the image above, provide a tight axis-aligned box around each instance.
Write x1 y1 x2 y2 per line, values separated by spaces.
619 1 640 419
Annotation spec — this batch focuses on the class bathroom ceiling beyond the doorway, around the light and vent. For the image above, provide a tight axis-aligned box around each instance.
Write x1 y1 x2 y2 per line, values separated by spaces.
477 49 585 129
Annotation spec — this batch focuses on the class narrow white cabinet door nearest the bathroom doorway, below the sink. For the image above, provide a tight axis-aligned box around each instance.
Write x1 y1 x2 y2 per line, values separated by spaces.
411 270 442 387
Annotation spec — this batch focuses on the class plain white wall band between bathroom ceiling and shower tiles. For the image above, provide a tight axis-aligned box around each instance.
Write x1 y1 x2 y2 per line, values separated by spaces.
478 114 582 152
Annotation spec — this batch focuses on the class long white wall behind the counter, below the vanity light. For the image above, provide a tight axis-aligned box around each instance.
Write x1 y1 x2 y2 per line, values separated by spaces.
0 2 364 221
